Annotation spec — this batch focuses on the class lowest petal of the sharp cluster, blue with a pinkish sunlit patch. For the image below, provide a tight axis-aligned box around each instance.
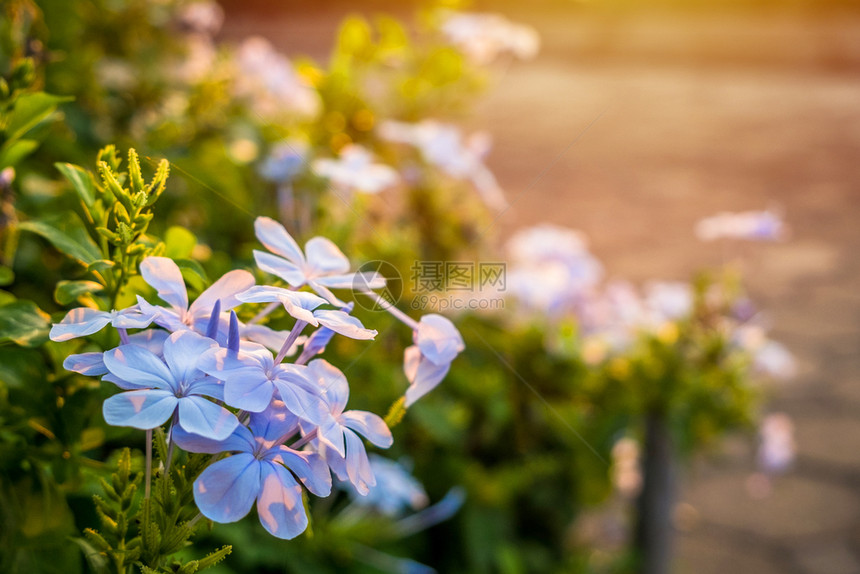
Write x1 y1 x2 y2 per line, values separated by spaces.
257 462 308 540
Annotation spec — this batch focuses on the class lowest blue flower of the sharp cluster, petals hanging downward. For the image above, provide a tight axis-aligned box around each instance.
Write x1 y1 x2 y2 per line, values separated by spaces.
175 401 331 539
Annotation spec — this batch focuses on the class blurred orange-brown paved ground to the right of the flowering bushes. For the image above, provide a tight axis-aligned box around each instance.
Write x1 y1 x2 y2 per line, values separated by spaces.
220 4 860 574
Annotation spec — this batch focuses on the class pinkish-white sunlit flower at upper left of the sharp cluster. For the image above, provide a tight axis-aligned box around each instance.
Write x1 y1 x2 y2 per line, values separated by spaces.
137 257 254 334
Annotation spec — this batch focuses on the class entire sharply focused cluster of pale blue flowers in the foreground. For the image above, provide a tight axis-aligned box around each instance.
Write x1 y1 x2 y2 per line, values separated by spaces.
51 217 463 538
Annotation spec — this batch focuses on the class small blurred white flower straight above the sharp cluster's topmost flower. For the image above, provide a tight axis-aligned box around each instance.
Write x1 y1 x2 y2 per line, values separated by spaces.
311 144 400 193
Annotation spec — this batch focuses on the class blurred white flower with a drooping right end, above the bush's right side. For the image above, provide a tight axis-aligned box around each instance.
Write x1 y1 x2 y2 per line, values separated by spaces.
379 120 508 210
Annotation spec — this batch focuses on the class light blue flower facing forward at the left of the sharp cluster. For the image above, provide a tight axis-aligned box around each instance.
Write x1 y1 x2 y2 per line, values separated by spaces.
102 331 239 439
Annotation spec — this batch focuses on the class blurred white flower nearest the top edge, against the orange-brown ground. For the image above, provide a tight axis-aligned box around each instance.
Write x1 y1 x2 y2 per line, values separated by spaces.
442 12 540 65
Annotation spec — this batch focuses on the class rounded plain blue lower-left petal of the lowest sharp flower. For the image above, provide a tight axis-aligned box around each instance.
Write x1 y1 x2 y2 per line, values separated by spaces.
194 453 261 523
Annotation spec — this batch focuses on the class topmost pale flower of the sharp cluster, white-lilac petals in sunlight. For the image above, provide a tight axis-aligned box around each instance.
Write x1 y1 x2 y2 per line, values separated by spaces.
254 217 385 307
